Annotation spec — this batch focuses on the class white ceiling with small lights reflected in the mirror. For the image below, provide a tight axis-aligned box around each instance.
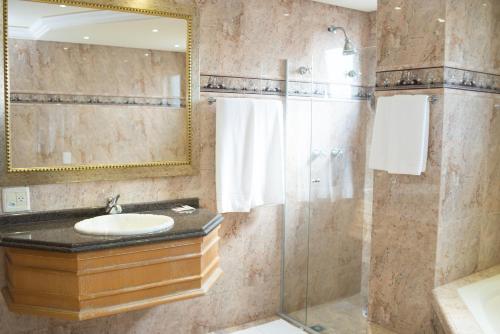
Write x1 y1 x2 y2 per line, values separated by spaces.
9 0 187 52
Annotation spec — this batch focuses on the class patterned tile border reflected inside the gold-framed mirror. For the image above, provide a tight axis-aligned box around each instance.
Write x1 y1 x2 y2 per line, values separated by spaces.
10 92 185 107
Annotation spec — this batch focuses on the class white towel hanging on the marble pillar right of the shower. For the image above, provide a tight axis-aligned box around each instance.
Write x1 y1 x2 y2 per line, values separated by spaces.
369 95 429 175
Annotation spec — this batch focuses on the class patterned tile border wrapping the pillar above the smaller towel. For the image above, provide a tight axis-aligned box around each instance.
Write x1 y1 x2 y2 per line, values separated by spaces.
375 67 500 94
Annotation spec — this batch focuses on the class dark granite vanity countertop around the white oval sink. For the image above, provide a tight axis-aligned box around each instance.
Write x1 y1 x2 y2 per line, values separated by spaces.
0 199 223 253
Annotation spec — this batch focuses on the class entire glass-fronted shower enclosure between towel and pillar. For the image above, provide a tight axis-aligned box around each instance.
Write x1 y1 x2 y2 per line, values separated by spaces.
281 37 375 333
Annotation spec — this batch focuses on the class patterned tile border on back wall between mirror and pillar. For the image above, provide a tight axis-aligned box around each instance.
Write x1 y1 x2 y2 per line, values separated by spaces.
200 74 374 100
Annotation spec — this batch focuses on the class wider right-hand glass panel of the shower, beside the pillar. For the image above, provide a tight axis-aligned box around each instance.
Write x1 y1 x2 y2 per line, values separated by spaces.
305 35 374 333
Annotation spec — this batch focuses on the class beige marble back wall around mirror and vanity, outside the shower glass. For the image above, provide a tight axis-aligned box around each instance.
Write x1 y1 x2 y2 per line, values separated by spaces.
0 0 374 334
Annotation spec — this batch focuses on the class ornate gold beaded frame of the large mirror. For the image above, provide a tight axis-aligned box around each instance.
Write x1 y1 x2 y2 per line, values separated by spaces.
0 0 198 185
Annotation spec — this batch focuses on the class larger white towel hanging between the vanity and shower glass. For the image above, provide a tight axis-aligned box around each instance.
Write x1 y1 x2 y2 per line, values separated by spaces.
216 98 285 213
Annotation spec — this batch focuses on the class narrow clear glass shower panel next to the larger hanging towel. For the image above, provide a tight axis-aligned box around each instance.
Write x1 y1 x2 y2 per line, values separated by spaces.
281 58 312 324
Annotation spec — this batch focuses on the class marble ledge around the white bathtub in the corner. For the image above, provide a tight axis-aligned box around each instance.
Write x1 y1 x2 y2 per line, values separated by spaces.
432 265 500 334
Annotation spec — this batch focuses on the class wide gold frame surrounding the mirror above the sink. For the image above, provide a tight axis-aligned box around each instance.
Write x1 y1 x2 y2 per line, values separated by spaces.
0 0 199 186
